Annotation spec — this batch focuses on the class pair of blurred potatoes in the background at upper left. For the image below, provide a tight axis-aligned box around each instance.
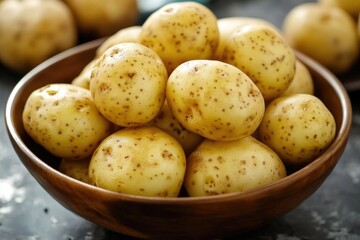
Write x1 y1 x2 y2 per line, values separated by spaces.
0 0 139 73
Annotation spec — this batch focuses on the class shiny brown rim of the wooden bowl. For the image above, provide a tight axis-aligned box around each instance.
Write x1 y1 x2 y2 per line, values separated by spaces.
5 38 352 205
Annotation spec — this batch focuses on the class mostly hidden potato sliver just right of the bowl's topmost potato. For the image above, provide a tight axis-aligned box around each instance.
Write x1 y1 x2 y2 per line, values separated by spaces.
214 17 280 61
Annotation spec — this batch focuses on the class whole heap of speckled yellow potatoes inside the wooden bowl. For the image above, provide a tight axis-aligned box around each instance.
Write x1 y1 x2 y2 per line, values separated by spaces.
23 2 336 197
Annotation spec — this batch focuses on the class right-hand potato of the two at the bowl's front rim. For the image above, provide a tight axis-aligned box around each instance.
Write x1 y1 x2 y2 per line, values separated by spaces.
184 136 286 197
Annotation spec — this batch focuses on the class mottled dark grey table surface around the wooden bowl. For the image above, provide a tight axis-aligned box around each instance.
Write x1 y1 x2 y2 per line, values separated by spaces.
0 0 360 240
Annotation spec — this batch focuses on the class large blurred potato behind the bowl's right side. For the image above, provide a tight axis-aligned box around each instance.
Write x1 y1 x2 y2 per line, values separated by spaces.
283 3 359 74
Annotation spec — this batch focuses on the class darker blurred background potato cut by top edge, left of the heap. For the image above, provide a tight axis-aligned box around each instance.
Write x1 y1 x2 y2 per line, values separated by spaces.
64 0 140 38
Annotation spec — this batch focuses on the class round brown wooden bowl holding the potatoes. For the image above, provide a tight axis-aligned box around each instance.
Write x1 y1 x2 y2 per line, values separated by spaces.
5 40 352 239
